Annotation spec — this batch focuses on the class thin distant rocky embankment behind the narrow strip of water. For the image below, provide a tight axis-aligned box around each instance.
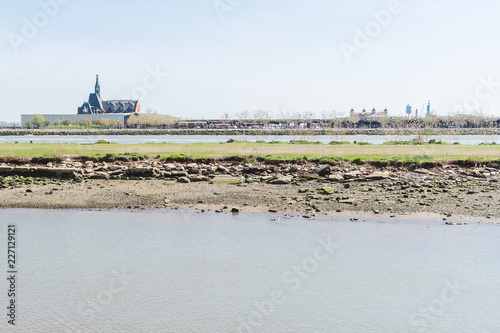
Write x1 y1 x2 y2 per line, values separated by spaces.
0 128 500 136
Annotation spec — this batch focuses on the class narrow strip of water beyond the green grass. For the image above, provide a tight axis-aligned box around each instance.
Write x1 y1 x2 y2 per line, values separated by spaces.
0 135 500 145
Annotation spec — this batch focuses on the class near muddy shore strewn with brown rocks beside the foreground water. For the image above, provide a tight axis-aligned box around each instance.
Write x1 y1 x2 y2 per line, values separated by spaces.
0 157 500 221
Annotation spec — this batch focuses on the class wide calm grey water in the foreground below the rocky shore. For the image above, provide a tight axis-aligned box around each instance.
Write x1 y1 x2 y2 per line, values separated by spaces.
0 210 500 332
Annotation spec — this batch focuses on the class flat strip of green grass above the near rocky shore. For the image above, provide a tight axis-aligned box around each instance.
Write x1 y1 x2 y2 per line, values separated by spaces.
0 142 500 162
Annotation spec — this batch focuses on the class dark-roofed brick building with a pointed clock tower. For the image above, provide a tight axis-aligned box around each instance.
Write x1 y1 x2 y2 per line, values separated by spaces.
78 75 141 115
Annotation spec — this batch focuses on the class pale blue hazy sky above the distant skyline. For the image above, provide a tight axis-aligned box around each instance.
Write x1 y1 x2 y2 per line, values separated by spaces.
0 0 500 121
